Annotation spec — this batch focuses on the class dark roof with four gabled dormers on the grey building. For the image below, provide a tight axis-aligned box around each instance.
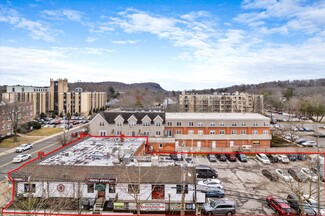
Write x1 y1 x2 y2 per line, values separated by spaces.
100 111 166 124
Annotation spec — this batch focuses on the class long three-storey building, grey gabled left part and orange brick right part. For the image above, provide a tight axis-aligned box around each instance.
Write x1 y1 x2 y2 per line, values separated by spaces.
90 111 271 152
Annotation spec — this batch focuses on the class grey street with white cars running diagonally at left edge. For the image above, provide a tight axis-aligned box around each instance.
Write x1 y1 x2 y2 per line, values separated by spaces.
0 125 85 181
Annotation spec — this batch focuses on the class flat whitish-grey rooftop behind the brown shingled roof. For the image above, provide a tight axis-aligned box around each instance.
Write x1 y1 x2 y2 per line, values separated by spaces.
39 137 146 166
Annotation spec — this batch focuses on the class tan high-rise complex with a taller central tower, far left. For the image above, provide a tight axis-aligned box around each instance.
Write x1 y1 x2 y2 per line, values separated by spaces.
2 79 107 116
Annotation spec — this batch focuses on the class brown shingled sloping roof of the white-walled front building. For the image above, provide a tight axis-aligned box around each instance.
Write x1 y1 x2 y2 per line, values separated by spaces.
11 164 196 184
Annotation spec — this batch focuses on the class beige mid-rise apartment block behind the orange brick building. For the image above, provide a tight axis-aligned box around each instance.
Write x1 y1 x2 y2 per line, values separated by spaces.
179 91 263 113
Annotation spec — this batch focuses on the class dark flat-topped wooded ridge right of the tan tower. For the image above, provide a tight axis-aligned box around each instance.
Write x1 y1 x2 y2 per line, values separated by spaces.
68 82 167 92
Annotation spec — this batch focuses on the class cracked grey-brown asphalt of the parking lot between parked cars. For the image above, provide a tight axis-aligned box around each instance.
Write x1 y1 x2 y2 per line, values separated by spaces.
194 156 325 215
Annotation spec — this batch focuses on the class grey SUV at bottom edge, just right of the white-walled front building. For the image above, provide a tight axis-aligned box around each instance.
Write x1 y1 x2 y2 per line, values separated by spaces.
201 199 236 215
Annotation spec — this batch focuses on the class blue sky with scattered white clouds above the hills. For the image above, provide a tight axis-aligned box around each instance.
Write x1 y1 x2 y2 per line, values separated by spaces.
0 0 325 90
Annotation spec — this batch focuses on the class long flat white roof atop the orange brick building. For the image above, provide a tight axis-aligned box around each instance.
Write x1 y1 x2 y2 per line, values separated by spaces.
166 112 270 121
